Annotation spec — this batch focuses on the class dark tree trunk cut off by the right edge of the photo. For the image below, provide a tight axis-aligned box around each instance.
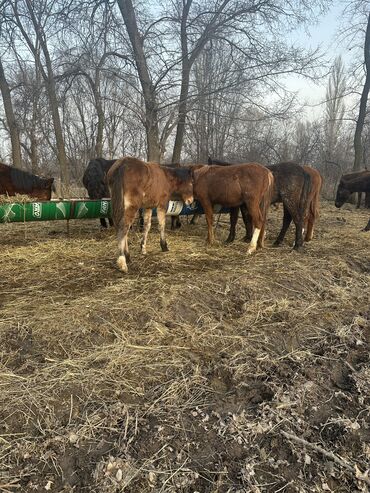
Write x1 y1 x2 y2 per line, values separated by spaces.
353 14 370 171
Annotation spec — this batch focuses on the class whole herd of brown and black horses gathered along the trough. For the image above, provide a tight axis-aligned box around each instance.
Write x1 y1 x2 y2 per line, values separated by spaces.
0 157 370 272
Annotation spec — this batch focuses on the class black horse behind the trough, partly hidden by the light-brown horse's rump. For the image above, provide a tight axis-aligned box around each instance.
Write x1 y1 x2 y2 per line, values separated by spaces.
82 157 117 228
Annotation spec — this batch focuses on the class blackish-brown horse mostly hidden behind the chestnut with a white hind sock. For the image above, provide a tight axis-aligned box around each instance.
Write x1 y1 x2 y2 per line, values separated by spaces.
209 158 311 250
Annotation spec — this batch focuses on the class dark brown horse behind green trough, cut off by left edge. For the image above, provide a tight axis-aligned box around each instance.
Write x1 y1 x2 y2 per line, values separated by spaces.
0 163 55 200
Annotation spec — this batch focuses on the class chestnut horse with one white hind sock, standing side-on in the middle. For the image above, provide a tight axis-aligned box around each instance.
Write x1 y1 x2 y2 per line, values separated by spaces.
193 163 274 254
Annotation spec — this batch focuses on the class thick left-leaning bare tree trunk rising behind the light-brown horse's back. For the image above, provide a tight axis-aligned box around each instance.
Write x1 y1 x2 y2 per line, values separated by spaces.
117 0 161 162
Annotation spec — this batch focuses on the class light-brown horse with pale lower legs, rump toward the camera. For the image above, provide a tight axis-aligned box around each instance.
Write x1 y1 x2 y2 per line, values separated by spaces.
107 156 194 272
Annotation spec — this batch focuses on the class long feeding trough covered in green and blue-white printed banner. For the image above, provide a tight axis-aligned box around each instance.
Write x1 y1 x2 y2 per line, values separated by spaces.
0 199 228 223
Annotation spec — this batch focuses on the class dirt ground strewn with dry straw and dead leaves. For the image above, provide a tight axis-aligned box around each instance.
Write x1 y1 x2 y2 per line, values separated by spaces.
0 204 370 493
